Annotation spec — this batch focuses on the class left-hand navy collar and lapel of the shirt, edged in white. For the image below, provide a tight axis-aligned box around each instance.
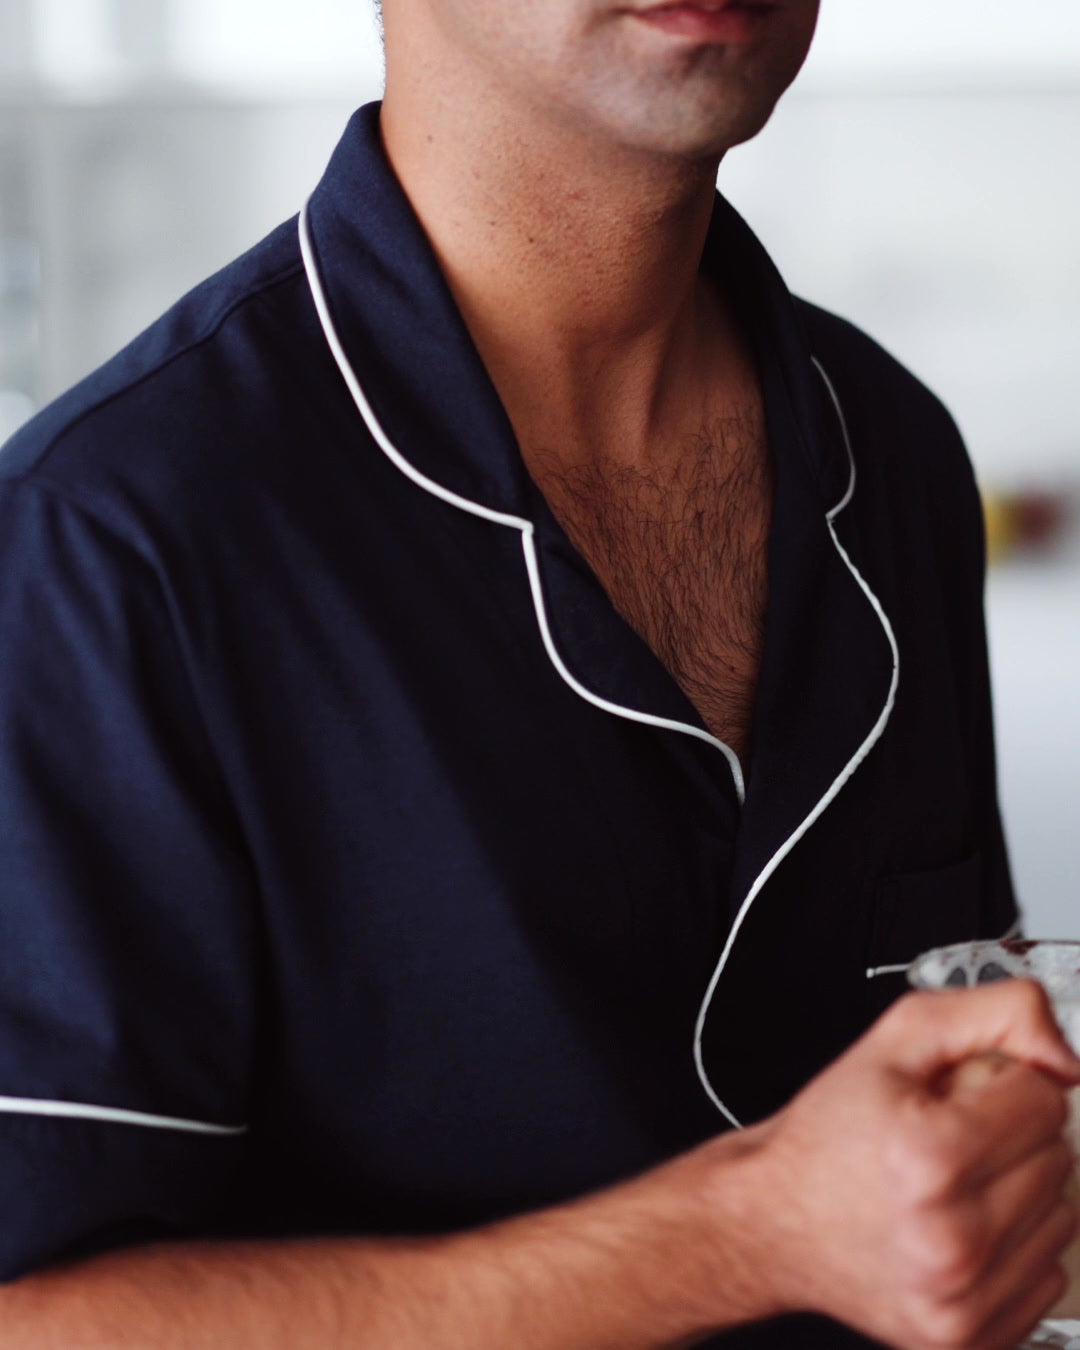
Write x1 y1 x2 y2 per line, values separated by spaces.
308 104 745 756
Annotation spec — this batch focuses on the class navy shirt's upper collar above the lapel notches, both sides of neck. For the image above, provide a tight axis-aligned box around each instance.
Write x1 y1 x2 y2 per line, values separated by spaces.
301 103 846 518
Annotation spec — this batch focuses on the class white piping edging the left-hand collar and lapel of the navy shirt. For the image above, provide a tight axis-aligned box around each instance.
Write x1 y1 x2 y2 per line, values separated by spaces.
300 204 747 806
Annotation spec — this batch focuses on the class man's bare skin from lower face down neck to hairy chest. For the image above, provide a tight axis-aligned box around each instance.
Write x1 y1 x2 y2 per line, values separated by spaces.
381 0 817 759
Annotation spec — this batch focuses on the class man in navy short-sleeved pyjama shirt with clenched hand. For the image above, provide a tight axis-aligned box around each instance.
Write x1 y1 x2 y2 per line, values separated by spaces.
0 0 1080 1350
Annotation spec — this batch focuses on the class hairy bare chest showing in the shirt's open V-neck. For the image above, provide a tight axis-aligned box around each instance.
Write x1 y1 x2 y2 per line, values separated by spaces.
529 413 772 757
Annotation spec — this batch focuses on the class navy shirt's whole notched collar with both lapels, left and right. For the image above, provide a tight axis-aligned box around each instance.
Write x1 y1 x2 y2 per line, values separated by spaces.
301 104 891 864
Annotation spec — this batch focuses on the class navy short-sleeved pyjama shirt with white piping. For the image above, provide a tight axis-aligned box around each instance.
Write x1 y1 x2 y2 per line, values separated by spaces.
0 105 1015 1345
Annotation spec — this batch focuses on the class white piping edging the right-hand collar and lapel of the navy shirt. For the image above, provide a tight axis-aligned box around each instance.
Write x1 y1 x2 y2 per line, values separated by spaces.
694 356 900 1129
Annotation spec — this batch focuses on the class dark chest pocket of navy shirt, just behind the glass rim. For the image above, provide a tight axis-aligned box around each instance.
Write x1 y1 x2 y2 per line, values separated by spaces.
867 852 1003 1017
